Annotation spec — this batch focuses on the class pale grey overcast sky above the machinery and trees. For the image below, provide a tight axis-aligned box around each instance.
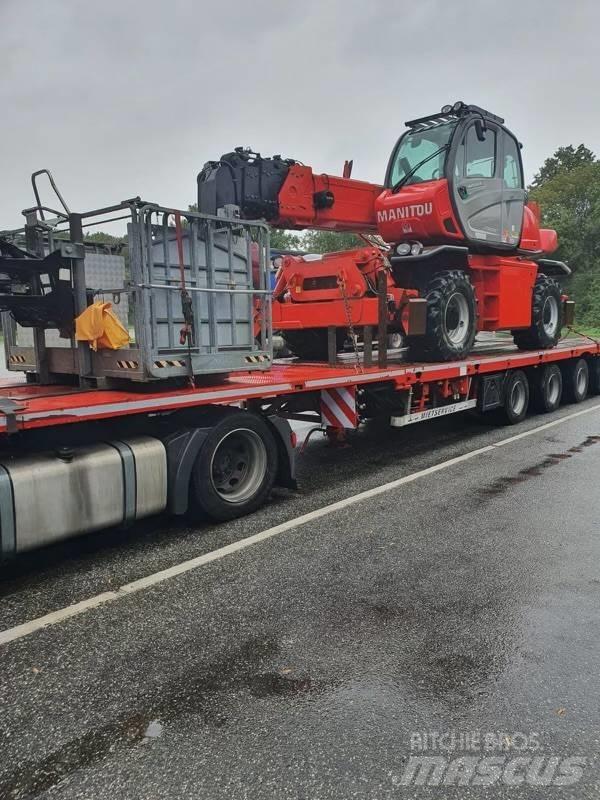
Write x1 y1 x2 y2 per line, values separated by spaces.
0 0 600 229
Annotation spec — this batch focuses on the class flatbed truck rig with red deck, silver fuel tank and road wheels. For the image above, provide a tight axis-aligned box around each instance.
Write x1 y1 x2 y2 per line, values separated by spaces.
0 337 600 557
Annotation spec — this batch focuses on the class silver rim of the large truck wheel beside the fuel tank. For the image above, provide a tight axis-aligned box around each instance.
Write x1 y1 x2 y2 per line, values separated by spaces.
210 428 267 503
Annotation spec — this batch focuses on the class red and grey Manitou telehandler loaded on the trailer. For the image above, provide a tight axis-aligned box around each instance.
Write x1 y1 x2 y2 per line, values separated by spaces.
198 102 570 361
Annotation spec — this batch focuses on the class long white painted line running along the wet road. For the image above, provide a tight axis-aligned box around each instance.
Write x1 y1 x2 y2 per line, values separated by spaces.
0 404 600 645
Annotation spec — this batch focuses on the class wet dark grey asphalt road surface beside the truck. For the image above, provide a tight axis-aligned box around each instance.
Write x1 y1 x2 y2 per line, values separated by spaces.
0 398 600 800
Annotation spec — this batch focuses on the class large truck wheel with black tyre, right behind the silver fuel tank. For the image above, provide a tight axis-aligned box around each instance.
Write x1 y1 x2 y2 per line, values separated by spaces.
190 411 278 521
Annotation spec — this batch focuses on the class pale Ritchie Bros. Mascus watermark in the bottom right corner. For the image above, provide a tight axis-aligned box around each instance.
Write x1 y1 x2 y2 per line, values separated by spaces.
395 731 588 786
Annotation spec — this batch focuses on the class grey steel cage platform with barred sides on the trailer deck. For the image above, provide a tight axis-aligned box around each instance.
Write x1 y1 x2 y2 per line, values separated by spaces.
2 198 272 381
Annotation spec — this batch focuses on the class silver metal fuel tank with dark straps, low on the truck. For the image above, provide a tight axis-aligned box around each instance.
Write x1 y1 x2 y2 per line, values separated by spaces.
0 436 167 556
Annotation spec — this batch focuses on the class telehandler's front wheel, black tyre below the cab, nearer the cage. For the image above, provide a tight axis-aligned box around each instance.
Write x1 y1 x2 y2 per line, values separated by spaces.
407 270 477 361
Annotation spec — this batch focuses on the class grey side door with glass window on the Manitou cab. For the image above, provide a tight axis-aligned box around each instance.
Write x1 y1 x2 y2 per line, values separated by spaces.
452 122 504 245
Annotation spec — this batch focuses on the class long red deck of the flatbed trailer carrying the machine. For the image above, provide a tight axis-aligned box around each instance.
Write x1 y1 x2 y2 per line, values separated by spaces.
0 337 600 433
